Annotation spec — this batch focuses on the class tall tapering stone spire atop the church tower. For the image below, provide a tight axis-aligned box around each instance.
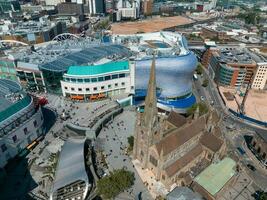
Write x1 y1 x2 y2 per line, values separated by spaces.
143 55 158 128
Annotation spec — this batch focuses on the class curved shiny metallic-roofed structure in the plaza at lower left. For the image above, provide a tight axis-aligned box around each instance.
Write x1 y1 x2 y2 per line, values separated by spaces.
50 139 92 200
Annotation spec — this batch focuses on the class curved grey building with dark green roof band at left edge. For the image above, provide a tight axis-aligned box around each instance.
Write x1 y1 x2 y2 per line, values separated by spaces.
0 79 43 168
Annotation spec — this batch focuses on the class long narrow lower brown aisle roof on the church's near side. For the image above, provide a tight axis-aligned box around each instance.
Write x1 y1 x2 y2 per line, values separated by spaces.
165 144 203 177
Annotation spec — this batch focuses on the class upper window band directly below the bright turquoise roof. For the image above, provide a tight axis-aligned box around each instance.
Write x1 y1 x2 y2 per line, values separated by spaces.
63 73 129 83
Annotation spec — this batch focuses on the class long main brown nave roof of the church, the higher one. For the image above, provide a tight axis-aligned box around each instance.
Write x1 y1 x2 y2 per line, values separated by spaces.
155 116 206 156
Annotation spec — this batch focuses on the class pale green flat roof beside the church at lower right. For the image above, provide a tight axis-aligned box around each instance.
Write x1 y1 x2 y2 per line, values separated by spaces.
194 158 236 196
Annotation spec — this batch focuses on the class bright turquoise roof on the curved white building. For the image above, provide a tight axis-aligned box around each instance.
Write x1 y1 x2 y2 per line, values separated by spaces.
67 61 129 76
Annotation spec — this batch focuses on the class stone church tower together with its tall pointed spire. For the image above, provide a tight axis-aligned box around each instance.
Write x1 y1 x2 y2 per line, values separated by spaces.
133 57 160 168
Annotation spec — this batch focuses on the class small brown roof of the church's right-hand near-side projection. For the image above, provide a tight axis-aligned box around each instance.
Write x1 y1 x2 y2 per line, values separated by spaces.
200 133 223 152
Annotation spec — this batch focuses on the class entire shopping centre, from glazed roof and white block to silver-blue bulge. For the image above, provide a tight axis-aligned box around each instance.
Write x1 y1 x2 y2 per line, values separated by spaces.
3 31 197 112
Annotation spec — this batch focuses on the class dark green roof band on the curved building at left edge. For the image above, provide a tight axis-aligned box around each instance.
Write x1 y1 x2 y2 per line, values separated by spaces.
0 95 31 122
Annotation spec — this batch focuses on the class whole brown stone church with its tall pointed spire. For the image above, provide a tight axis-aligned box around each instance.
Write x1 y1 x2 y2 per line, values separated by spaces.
133 57 226 189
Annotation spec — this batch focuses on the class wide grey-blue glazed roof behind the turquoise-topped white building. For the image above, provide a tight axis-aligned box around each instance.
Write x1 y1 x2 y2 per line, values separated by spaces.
12 38 131 72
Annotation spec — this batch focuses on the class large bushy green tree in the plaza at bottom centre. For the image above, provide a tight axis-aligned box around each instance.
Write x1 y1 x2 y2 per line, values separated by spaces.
97 169 135 199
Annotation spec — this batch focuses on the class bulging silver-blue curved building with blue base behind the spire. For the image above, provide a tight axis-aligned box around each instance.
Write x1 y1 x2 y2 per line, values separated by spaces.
113 32 197 112
